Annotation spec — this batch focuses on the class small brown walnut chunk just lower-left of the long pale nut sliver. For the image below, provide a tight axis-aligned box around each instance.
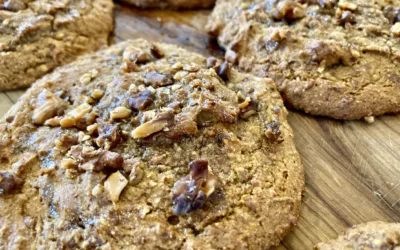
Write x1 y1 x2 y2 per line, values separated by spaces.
96 119 121 149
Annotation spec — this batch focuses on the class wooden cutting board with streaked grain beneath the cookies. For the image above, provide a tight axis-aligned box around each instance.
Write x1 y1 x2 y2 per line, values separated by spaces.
0 6 400 249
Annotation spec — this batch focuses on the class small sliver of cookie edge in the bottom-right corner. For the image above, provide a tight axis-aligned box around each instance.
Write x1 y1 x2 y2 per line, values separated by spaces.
314 221 400 250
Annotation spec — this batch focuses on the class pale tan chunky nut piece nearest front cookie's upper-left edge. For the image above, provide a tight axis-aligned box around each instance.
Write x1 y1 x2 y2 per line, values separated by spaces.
32 89 64 125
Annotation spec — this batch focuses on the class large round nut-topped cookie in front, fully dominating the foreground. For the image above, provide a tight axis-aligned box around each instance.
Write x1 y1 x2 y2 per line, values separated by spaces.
0 40 304 249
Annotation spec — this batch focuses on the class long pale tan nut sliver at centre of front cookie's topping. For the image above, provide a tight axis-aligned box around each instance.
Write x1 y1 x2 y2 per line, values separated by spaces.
132 110 174 139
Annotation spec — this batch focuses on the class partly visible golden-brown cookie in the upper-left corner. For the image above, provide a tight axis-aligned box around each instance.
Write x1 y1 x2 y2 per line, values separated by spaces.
0 0 113 90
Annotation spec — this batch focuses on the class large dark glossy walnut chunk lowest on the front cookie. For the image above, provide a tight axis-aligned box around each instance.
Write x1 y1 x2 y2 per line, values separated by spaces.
172 159 220 215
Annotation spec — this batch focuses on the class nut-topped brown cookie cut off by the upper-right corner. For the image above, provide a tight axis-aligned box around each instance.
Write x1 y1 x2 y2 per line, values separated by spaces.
208 0 400 119
